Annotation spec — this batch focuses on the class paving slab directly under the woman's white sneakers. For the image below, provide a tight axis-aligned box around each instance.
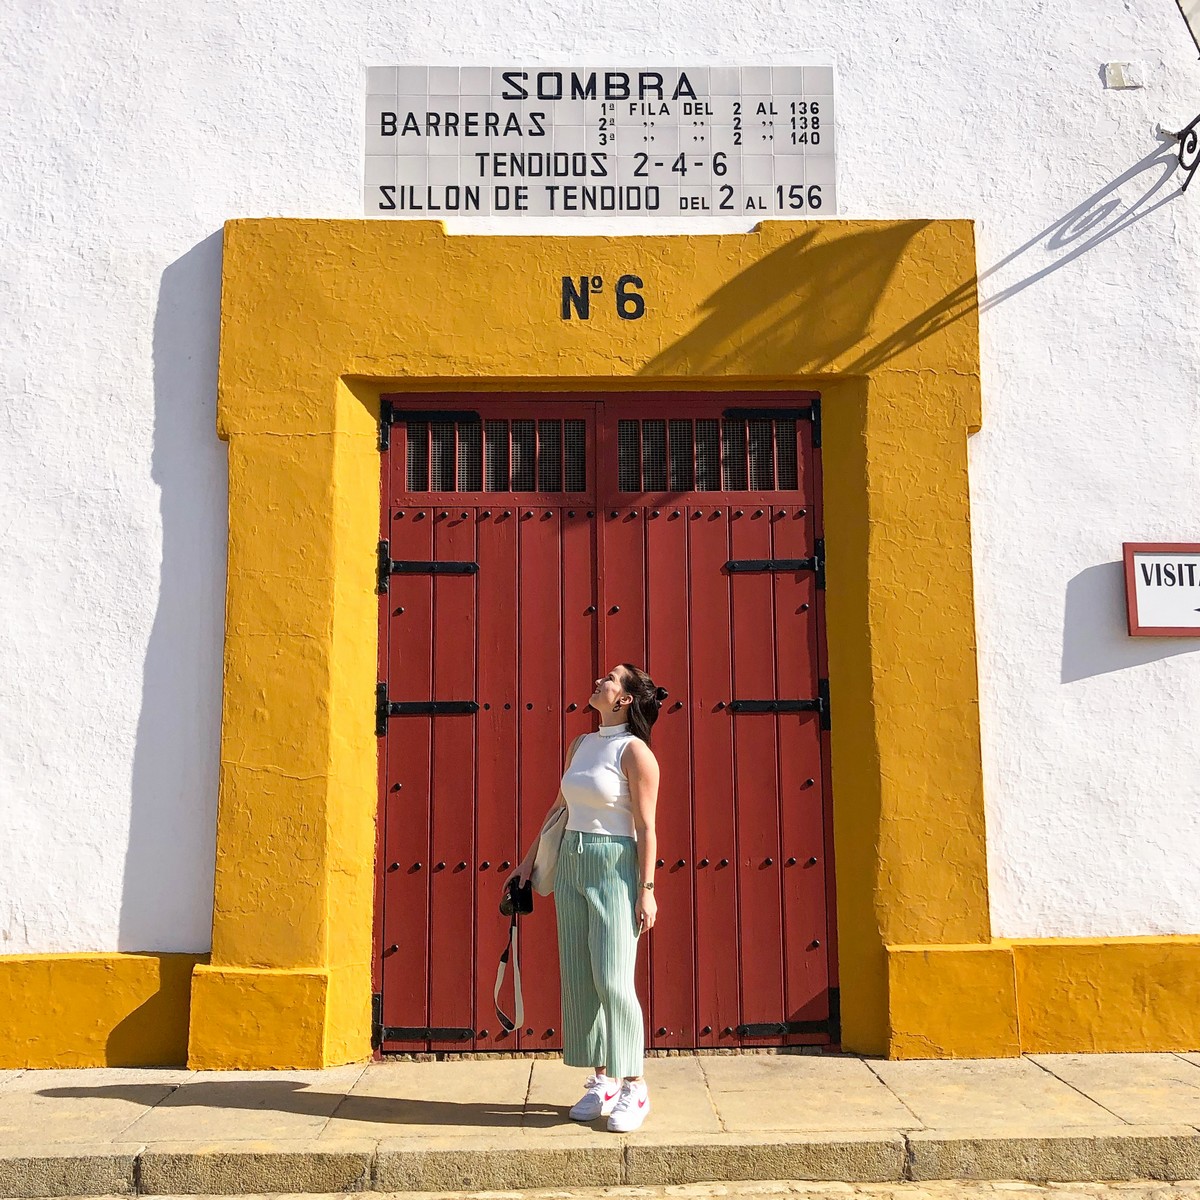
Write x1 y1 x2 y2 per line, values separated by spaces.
524 1057 721 1136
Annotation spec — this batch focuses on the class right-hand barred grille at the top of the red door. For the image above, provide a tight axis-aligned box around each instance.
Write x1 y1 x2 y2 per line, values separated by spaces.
617 416 799 492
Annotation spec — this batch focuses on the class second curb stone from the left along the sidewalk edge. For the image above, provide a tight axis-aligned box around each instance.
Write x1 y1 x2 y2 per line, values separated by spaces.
138 1140 374 1195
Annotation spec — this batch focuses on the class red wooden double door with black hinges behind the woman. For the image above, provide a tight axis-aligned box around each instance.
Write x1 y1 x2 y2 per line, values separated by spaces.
376 395 836 1050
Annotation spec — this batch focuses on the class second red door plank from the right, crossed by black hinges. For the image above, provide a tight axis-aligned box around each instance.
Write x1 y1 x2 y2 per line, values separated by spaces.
730 504 784 1044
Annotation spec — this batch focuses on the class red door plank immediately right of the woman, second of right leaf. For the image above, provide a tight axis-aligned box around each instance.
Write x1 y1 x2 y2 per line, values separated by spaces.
644 508 696 1048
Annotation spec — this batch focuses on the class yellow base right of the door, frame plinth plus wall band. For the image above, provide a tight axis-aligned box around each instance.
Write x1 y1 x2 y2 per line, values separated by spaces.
887 936 1200 1058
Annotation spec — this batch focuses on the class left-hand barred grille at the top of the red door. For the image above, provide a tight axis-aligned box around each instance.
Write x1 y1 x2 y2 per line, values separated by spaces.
404 420 588 492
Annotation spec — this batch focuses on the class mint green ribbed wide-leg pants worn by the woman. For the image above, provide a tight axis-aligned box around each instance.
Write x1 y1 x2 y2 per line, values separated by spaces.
554 829 646 1079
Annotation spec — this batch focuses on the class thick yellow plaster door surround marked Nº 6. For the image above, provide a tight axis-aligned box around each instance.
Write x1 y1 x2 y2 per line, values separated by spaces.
190 220 989 1067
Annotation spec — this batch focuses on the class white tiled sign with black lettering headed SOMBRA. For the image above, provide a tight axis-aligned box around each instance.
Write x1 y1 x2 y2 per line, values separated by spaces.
362 66 838 220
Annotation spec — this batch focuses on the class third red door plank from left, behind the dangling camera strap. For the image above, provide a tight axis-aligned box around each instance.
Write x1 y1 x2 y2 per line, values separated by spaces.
475 506 522 1050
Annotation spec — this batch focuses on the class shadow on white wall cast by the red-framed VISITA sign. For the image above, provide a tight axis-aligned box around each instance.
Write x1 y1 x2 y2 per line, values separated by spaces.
1062 563 1200 683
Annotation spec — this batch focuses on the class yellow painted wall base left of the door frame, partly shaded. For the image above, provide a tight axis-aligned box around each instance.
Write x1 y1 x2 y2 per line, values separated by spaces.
0 954 204 1069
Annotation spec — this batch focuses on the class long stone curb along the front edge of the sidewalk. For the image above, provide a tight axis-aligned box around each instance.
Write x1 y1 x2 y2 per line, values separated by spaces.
7 1126 1200 1200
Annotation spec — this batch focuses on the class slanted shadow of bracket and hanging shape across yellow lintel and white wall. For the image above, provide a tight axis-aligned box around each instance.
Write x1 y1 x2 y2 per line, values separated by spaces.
641 142 1181 376
